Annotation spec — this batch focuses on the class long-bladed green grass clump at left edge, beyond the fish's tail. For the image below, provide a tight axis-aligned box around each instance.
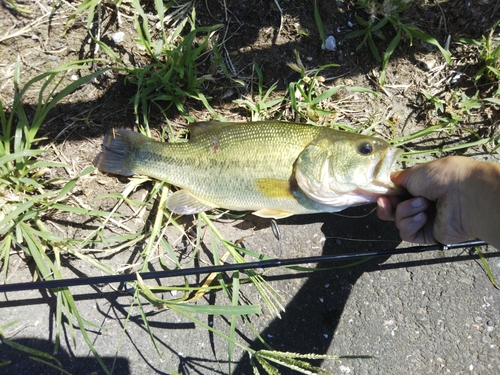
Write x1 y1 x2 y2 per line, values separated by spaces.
0 61 117 374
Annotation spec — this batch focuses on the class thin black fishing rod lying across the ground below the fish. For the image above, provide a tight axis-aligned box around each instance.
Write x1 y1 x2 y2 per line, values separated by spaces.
0 240 488 293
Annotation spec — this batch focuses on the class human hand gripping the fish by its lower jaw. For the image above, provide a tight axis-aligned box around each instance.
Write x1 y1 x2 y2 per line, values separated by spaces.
377 156 478 244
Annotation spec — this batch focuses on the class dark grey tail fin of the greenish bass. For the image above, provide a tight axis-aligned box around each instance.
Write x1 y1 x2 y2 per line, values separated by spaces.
94 129 150 176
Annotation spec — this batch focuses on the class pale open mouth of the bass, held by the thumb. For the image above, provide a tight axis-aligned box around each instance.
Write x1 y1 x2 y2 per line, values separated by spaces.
368 147 404 195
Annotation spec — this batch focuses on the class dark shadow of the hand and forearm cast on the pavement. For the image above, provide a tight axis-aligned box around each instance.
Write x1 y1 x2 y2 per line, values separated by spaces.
233 206 401 374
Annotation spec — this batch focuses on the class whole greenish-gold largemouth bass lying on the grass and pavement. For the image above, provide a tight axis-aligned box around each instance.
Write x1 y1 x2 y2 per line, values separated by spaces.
94 121 402 219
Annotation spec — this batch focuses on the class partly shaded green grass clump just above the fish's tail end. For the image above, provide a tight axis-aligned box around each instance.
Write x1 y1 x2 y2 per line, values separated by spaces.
128 1 220 125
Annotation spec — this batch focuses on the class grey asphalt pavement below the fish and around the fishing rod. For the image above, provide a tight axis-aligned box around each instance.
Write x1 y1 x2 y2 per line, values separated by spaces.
0 207 500 375
